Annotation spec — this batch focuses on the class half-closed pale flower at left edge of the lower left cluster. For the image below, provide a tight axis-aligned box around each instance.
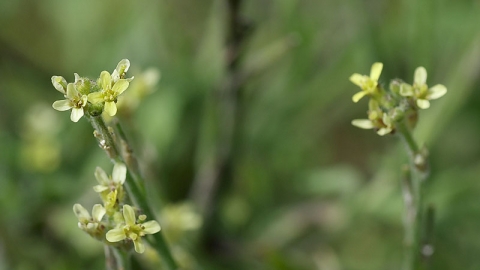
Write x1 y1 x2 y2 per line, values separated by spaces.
73 203 106 237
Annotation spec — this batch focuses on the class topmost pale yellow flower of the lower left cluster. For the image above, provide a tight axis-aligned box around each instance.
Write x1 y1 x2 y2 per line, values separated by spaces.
93 163 127 207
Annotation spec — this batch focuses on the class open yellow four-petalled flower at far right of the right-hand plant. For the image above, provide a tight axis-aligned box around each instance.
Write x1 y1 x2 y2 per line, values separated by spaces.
400 67 447 109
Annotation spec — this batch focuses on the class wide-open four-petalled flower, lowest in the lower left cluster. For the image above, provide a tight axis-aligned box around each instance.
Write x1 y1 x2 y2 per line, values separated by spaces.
105 204 160 253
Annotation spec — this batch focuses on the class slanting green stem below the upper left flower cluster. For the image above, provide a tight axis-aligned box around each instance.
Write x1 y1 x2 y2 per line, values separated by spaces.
86 115 178 270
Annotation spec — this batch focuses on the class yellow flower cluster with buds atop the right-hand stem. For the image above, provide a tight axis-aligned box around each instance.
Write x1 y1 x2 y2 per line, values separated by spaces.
350 62 447 136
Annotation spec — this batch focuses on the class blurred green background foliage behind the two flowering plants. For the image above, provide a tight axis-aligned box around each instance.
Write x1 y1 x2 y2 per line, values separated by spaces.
0 0 480 270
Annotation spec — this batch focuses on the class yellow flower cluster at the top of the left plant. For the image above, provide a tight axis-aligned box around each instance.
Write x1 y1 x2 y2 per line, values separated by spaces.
52 59 133 122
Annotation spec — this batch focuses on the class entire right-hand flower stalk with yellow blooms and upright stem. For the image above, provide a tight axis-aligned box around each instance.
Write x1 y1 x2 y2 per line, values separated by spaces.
350 63 447 270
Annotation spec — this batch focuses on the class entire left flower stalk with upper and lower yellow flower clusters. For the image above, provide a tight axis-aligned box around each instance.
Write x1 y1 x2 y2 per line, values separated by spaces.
52 59 178 270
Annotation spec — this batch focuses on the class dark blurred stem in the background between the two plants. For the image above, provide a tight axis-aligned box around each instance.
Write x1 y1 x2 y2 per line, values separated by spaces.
191 0 248 233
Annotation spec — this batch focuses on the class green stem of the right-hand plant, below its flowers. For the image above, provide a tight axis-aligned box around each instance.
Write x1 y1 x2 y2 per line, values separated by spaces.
397 121 428 270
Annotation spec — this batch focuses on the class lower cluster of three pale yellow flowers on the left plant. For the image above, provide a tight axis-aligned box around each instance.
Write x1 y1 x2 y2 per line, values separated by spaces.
73 163 160 253
